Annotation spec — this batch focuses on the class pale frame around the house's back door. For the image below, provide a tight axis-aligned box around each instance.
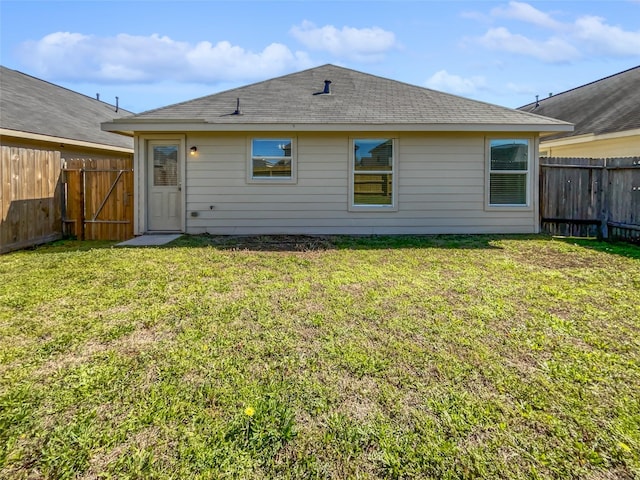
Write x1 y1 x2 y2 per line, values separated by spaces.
133 134 187 235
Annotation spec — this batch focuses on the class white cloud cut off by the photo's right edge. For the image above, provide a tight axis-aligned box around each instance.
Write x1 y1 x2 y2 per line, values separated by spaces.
575 16 640 56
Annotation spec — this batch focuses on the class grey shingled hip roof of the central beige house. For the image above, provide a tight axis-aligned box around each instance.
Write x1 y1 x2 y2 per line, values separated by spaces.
103 65 572 132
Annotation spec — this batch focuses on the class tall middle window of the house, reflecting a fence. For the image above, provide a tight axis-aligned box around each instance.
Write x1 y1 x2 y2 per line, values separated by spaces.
351 138 396 209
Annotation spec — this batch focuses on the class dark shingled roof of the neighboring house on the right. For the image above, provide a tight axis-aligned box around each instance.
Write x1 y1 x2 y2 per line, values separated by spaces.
518 66 640 141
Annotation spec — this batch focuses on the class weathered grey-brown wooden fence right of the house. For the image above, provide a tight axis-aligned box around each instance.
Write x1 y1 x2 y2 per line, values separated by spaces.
540 157 640 242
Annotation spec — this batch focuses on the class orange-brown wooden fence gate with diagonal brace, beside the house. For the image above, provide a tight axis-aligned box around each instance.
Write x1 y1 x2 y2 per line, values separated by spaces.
64 159 133 240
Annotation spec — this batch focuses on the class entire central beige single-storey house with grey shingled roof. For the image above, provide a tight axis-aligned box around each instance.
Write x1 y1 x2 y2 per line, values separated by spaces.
102 65 573 235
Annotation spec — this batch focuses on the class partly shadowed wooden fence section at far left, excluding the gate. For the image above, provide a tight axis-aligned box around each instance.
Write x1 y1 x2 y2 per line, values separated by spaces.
0 146 62 253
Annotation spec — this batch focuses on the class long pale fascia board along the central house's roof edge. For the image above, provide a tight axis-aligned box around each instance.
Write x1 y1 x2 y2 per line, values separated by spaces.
102 121 573 132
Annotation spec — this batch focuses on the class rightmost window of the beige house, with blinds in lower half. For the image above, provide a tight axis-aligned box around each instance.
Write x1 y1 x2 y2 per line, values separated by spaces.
488 139 529 206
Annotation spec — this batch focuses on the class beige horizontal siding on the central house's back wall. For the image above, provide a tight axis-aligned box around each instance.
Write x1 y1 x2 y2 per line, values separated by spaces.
174 132 537 234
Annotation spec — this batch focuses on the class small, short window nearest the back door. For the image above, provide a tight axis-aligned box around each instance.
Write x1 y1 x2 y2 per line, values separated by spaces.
248 138 295 183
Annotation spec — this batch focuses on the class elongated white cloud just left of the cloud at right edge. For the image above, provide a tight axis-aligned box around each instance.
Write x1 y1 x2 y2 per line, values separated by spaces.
479 27 581 63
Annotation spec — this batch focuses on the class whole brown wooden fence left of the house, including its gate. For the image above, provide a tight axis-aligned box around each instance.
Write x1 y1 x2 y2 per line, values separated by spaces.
0 149 133 253
